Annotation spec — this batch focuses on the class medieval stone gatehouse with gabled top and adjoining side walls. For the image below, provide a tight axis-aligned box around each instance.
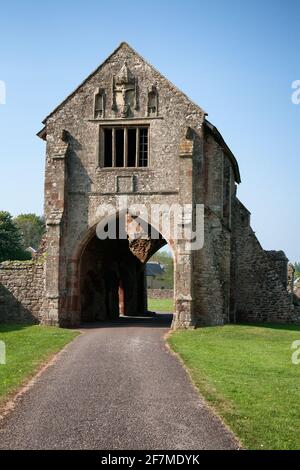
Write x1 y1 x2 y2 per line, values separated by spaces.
0 43 296 327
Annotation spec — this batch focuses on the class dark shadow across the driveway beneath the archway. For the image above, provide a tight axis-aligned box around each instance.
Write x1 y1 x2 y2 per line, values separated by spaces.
79 313 173 330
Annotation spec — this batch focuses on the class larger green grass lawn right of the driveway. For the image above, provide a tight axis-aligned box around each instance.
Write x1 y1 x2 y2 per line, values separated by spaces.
168 325 300 449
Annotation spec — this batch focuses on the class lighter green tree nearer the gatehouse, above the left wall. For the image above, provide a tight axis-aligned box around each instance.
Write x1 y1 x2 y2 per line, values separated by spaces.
14 214 45 250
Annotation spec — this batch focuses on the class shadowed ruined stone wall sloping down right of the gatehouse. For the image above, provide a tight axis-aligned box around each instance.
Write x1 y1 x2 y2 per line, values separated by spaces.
231 199 297 322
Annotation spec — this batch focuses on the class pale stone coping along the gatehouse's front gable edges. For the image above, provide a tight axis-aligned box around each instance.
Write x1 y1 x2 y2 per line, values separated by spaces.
40 41 206 125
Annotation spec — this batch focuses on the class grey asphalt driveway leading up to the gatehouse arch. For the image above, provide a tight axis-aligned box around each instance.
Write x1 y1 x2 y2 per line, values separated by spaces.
0 315 237 450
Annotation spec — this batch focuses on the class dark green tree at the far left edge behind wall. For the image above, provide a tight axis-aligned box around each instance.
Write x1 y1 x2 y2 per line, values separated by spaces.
0 211 30 262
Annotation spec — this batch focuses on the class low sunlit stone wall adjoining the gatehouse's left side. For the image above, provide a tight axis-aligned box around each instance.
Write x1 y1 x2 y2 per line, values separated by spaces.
0 259 44 323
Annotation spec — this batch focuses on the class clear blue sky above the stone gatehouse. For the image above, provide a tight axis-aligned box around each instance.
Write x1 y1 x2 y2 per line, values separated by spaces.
0 0 300 261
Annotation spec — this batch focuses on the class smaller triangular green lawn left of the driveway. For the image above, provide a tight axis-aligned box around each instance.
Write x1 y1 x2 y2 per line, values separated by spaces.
0 324 78 405
